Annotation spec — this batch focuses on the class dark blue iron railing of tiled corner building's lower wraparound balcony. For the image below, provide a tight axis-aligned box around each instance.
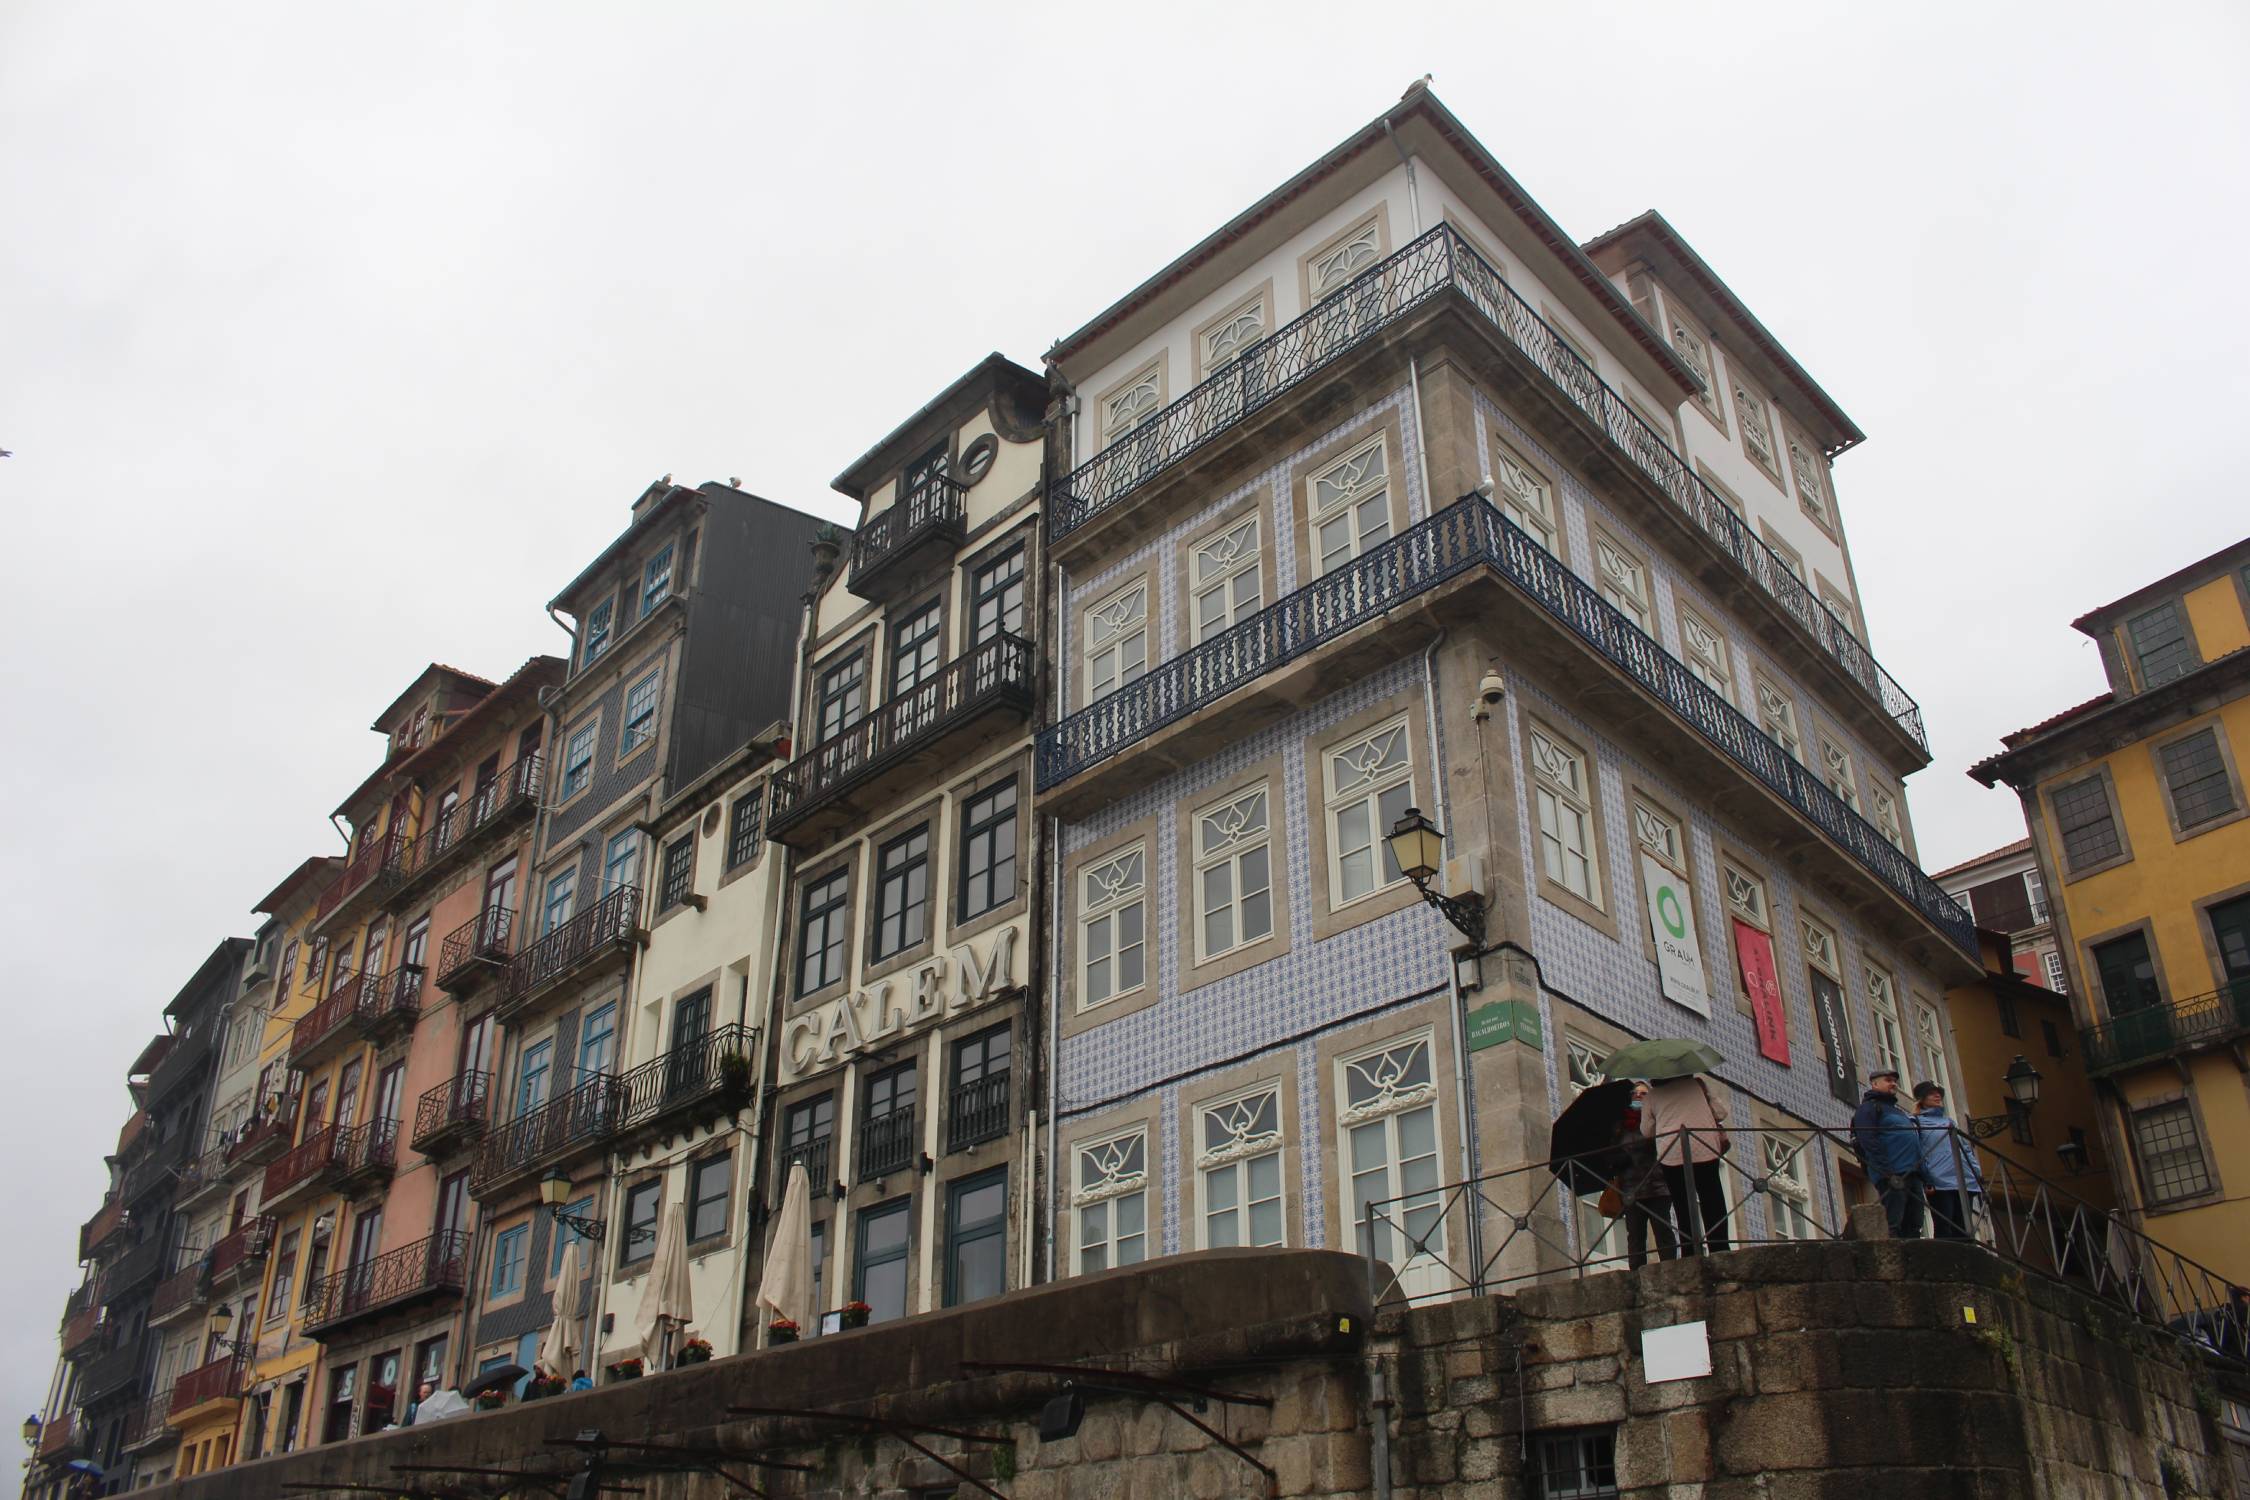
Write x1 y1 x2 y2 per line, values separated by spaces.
1037 495 1978 956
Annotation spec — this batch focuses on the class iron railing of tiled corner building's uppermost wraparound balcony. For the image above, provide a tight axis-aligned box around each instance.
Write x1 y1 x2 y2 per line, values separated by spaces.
1046 225 1928 751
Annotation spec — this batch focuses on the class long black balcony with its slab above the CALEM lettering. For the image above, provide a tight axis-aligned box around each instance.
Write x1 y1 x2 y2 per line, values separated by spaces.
767 634 1033 848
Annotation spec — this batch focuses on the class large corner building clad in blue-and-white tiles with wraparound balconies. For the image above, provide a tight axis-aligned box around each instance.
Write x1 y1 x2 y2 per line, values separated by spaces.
1037 88 1978 1293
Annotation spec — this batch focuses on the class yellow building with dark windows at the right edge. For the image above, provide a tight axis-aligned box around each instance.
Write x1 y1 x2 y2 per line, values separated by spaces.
1969 540 2250 1282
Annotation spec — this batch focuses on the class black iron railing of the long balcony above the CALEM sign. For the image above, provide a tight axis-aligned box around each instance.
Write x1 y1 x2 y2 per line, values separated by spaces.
767 632 1033 834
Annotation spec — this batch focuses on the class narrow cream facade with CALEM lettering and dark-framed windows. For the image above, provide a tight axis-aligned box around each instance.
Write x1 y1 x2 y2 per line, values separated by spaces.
767 355 1046 1331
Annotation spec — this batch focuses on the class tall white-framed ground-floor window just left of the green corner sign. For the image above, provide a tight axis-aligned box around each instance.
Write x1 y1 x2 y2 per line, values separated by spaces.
1337 1032 1445 1293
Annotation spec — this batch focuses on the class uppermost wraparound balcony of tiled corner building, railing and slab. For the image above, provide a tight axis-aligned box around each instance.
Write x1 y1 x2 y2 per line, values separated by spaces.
1046 225 1928 765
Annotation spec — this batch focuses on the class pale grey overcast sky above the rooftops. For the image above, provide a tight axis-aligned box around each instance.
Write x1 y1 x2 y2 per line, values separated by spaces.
0 0 2250 1448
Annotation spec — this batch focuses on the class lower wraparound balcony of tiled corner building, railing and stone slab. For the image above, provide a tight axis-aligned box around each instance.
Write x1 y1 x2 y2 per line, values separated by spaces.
1037 495 1978 958
